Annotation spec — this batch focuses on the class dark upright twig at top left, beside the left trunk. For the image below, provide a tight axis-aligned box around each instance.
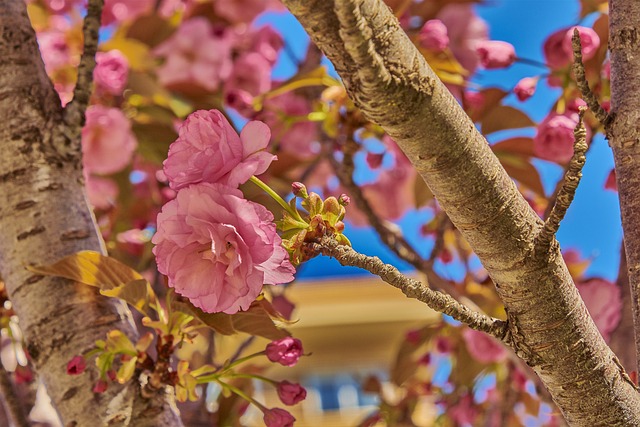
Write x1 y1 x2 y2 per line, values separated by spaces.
64 0 104 135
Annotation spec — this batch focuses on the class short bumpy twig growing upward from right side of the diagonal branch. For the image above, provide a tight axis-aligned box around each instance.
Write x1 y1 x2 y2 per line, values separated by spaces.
536 107 587 248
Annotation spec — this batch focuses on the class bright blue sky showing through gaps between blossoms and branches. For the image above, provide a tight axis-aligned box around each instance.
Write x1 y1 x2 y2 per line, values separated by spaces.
258 0 622 280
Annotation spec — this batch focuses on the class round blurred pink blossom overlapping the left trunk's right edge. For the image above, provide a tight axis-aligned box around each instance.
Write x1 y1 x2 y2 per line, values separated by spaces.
82 105 138 174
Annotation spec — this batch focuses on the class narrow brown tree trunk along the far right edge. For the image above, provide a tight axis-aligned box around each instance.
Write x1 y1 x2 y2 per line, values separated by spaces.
607 0 640 378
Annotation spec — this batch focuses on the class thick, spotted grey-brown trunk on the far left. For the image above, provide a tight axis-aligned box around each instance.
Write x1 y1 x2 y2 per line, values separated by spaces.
0 0 181 426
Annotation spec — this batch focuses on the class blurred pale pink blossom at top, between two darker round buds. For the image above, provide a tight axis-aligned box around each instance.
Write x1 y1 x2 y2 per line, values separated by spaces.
437 3 489 72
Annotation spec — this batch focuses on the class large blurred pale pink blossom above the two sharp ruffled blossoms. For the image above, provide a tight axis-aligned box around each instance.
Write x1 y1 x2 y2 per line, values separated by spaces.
153 17 233 91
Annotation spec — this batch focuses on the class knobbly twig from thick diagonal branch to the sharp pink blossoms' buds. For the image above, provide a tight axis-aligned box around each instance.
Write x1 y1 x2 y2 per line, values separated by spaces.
313 236 507 340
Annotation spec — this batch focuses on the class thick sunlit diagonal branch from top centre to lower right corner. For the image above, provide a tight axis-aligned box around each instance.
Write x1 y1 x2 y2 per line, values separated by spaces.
284 0 640 427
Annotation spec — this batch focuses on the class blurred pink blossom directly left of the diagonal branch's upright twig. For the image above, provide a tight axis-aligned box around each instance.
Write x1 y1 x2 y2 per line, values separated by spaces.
533 113 578 163
